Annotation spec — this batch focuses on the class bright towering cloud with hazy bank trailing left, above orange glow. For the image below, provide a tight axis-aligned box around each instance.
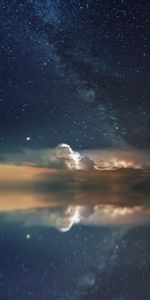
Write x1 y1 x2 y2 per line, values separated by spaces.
3 143 96 170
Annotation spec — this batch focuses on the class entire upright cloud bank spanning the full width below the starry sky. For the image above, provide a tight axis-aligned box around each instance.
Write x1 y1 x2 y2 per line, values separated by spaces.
3 143 150 170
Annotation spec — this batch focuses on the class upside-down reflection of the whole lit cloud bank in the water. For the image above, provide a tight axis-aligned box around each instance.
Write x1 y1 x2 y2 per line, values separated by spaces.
4 204 150 232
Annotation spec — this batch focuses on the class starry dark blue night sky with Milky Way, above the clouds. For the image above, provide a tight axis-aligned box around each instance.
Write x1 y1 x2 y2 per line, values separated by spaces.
0 0 150 151
